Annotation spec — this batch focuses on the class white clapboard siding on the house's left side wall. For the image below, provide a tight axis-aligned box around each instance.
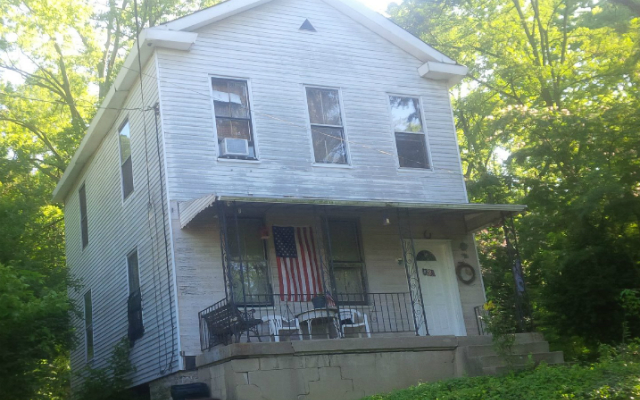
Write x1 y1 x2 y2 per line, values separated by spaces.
65 58 178 387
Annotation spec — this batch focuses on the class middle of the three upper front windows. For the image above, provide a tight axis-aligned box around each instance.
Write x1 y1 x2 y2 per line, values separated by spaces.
307 87 347 164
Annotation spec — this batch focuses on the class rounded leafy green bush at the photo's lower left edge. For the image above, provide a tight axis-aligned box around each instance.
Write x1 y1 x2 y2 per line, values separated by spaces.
0 264 73 400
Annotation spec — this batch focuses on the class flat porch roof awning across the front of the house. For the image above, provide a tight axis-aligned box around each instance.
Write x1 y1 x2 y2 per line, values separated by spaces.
178 194 527 232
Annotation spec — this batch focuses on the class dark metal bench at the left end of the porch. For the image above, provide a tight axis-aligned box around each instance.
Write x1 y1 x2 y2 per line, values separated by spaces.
202 299 262 348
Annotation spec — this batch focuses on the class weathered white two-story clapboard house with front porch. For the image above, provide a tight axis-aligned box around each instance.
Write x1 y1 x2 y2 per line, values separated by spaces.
54 0 560 400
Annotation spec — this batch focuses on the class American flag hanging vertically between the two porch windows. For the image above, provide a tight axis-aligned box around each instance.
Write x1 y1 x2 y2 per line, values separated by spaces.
273 226 322 301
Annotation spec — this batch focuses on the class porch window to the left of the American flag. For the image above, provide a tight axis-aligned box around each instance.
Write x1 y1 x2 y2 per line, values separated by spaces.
227 219 273 304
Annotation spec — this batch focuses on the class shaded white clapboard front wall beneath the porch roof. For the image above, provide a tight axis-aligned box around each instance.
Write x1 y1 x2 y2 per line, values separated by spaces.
173 207 485 355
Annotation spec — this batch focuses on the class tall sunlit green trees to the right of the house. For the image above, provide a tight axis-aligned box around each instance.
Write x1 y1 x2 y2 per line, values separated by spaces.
389 0 640 358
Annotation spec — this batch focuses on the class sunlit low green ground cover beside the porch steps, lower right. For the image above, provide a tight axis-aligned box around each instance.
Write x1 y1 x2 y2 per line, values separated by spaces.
365 342 640 400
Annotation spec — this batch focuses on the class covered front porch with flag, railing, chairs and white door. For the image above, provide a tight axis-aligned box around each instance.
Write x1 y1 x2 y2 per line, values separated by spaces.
178 195 524 351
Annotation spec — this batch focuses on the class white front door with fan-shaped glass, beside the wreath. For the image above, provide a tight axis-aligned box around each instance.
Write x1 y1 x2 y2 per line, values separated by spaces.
414 240 465 336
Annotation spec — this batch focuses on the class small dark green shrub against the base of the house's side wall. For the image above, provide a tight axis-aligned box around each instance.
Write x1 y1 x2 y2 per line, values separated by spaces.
74 337 138 400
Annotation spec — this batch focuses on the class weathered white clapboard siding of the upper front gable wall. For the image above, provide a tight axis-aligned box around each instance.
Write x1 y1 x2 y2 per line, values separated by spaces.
157 0 466 203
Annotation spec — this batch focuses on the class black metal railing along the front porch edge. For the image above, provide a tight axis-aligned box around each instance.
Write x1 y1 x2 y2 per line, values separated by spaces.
198 293 415 350
